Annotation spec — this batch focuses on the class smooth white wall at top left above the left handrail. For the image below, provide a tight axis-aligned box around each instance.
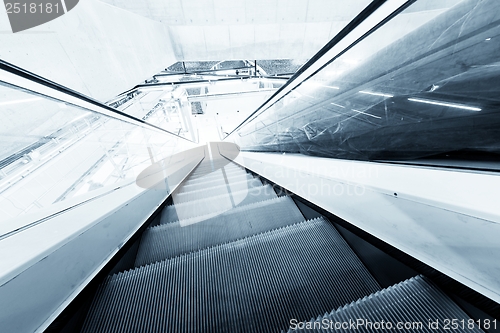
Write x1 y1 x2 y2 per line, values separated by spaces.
0 0 176 101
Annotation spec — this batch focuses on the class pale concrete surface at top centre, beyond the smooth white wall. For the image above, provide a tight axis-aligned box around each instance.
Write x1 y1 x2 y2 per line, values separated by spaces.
101 0 370 61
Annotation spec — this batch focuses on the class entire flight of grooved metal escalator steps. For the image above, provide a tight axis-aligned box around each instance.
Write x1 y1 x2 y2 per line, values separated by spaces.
81 150 481 333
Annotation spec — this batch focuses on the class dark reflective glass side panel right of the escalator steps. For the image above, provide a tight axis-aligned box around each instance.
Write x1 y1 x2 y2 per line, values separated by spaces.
228 0 500 167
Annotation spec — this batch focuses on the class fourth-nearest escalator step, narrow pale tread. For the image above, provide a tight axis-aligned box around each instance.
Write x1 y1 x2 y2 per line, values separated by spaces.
161 185 276 223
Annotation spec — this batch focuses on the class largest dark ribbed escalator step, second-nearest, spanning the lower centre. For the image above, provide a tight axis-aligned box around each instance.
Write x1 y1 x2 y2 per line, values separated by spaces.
82 218 380 333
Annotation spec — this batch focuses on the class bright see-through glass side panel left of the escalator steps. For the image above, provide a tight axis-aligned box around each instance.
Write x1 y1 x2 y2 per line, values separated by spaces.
0 84 196 226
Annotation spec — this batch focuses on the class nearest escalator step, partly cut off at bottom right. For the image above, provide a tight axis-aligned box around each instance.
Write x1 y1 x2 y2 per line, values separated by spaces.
288 276 482 333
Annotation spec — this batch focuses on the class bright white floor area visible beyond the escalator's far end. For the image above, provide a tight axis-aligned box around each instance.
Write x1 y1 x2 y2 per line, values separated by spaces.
124 74 287 143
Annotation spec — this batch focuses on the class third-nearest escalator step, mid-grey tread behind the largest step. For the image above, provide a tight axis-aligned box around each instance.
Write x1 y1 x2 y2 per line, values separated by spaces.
135 197 304 267
